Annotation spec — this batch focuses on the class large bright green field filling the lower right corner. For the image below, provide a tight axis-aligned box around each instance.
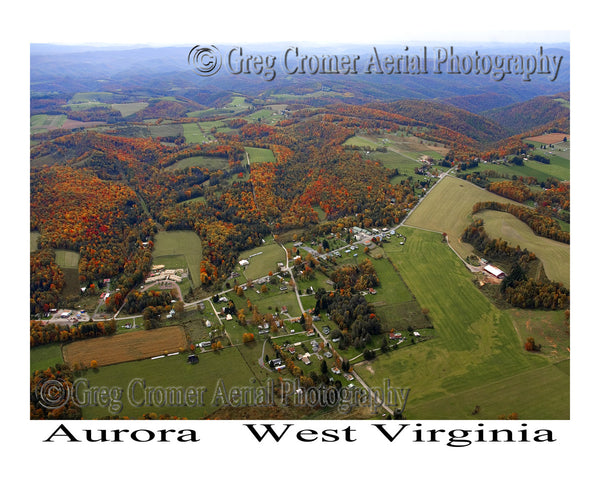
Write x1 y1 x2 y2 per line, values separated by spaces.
355 228 569 419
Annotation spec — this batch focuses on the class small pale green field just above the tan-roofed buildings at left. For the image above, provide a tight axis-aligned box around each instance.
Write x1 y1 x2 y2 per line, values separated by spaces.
152 230 202 286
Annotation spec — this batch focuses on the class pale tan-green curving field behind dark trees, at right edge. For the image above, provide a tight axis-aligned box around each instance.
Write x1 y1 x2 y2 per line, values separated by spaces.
474 210 571 287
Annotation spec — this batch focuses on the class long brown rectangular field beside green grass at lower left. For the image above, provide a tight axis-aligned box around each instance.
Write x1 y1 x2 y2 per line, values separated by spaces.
63 326 187 367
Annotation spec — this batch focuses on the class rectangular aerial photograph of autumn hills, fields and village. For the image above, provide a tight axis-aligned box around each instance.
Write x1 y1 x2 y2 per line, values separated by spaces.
29 37 571 421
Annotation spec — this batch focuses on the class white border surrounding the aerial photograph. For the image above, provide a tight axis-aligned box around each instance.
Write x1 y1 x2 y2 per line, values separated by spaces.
7 0 598 478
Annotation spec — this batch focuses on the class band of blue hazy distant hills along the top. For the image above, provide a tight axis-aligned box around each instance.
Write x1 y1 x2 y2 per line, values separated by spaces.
30 44 570 108
